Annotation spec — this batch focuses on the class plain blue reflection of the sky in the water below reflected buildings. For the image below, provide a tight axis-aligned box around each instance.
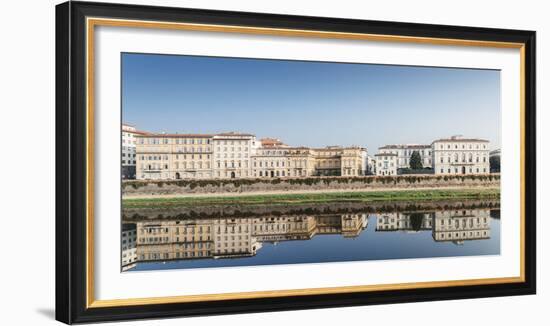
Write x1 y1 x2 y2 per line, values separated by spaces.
131 214 500 271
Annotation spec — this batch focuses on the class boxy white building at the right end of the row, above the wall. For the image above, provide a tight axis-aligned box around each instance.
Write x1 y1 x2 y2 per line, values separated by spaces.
432 136 489 174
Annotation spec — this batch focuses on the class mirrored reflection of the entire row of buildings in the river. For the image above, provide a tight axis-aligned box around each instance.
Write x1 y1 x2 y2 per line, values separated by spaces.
122 209 496 271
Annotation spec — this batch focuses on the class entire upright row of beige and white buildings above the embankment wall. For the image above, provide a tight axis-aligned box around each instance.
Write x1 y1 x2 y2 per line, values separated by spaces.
122 125 498 180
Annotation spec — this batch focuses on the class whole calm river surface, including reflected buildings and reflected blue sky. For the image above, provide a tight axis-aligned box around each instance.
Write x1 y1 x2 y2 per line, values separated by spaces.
122 201 500 271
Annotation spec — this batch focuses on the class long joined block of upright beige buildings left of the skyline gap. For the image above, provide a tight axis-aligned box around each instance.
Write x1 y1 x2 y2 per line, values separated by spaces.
135 132 367 180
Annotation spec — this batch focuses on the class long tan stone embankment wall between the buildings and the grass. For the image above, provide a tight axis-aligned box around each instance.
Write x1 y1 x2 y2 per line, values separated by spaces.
122 174 500 198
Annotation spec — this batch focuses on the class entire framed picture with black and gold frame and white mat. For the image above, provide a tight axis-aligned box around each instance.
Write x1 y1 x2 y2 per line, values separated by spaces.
56 1 536 324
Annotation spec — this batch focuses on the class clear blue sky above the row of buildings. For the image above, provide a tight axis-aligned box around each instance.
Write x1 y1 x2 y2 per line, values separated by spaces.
122 53 501 153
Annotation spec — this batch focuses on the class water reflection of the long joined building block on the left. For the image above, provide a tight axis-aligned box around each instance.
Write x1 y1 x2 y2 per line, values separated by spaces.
122 214 368 270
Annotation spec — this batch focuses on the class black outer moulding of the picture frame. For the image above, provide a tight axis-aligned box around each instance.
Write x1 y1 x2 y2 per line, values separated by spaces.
55 1 536 324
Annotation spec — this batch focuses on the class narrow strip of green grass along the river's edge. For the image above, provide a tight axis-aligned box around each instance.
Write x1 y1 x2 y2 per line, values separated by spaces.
122 187 500 209
